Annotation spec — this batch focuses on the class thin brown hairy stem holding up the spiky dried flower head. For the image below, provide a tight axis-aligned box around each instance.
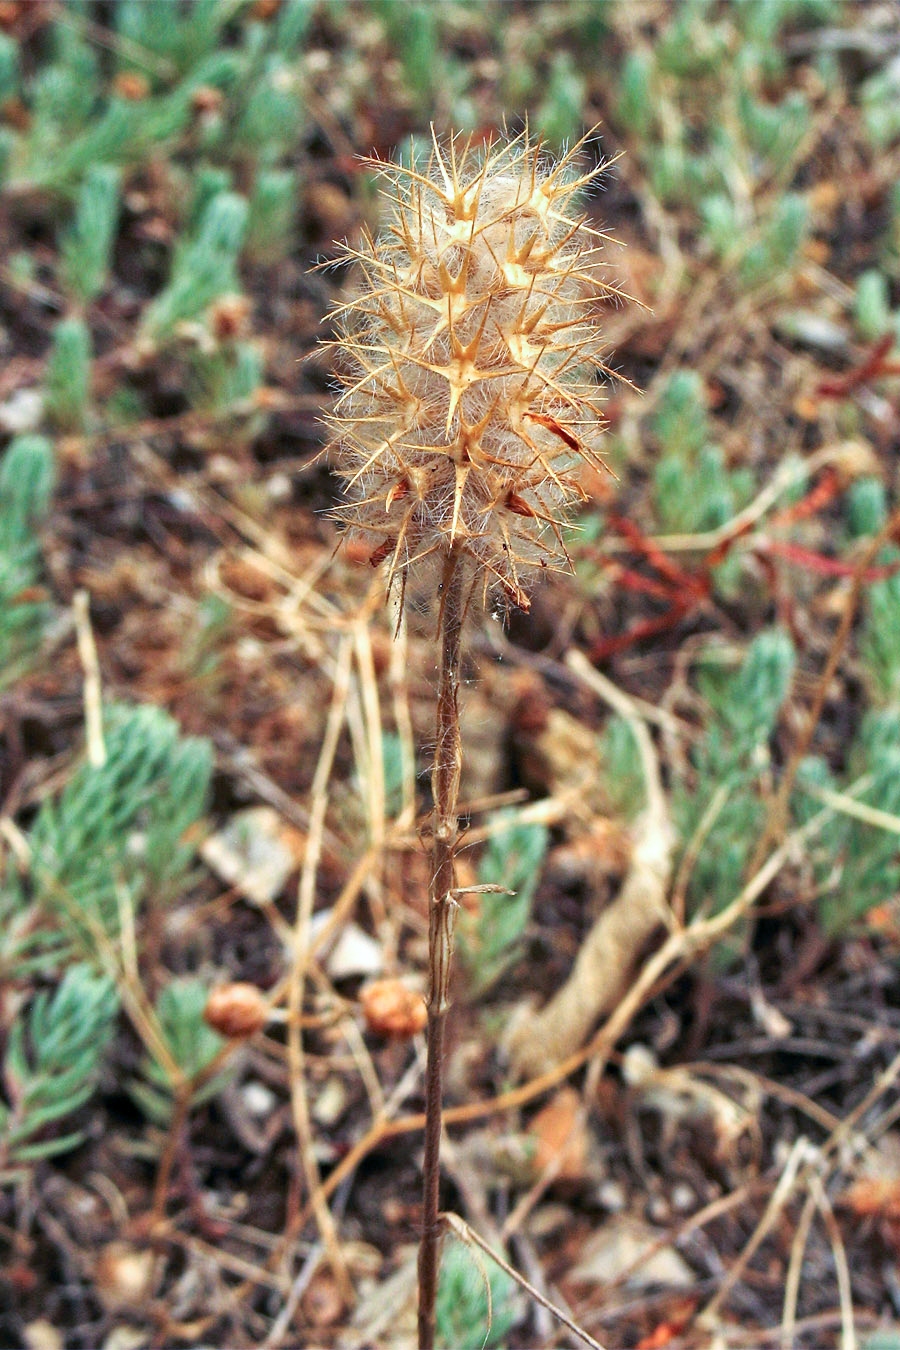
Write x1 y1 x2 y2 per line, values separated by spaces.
418 545 463 1350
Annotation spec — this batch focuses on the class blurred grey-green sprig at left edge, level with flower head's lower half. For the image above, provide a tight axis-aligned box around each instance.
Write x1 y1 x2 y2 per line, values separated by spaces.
0 436 55 690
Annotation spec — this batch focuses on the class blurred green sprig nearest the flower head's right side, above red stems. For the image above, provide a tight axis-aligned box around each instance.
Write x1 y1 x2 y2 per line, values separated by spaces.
653 370 753 542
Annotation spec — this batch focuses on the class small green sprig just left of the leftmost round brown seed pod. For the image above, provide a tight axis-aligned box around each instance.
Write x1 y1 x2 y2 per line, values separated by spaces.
128 977 228 1126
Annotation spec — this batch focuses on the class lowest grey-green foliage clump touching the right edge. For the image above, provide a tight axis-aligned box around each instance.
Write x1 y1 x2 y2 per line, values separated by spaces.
795 707 900 934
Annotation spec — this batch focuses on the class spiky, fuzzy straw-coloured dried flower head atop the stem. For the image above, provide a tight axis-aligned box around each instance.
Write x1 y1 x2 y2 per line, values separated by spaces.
323 132 626 608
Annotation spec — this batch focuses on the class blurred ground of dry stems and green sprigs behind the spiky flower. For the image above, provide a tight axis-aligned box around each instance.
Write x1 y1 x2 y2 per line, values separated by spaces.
0 0 900 1350
